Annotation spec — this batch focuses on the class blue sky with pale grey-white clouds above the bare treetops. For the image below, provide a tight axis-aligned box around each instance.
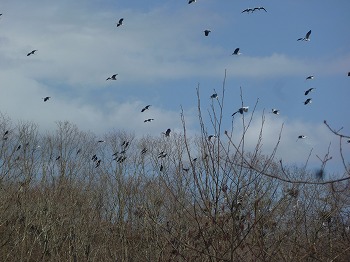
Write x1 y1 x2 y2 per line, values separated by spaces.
0 0 350 176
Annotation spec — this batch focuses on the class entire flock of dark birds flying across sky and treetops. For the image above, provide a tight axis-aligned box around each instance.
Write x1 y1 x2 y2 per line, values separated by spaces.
0 3 350 171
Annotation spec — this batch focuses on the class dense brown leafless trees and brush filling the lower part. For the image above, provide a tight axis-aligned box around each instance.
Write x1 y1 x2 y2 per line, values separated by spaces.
0 82 350 261
